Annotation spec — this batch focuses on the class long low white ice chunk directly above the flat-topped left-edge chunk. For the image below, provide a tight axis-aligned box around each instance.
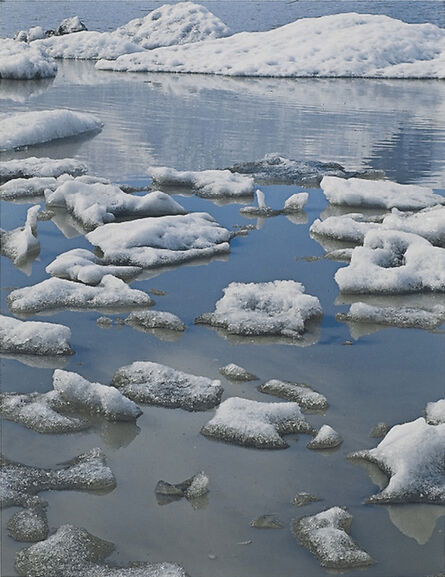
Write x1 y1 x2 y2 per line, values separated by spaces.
7 275 152 314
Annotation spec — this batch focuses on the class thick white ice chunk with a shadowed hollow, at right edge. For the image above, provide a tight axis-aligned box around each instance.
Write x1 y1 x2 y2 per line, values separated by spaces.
335 230 445 294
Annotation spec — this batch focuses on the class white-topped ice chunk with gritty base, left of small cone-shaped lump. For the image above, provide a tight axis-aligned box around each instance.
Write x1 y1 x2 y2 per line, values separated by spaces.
201 397 312 449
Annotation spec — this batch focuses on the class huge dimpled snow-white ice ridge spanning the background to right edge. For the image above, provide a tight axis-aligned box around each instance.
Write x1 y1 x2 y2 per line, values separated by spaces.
97 13 445 78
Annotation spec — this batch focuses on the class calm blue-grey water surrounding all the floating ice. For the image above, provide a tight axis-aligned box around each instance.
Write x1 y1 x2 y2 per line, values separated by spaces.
0 1 445 577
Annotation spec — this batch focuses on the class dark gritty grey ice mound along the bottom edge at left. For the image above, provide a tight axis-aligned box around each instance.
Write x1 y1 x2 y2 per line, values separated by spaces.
15 525 186 577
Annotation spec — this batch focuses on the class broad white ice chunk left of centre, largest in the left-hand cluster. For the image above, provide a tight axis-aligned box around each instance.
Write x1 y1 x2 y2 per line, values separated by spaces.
87 212 231 268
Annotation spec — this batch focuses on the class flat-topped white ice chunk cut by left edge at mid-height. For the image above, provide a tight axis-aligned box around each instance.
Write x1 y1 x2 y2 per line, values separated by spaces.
0 315 73 355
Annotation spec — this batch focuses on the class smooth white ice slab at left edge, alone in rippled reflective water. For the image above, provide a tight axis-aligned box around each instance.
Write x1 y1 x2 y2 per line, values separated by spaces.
0 110 103 151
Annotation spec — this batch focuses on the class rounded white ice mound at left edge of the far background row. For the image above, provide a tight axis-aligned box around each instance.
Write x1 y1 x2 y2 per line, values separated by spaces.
0 38 57 80
